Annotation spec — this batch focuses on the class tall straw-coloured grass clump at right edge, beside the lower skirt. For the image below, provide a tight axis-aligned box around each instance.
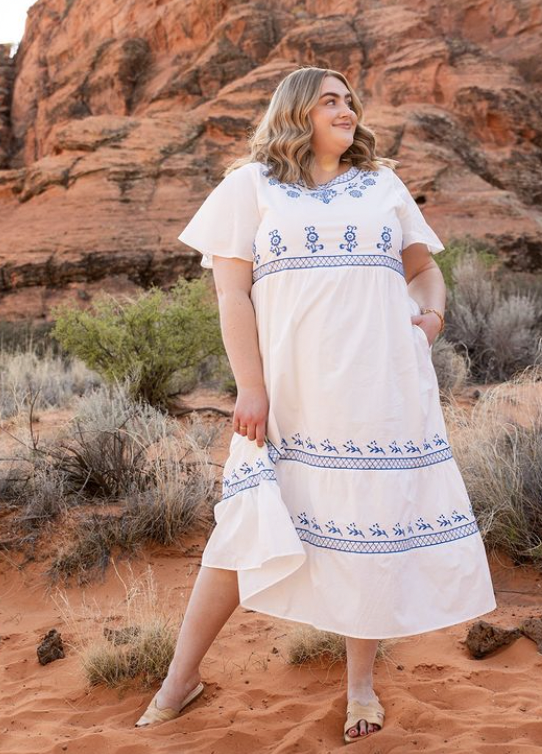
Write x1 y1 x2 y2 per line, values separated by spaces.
445 367 542 565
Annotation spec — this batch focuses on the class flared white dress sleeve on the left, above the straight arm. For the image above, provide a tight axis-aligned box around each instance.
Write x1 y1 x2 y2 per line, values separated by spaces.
178 163 260 269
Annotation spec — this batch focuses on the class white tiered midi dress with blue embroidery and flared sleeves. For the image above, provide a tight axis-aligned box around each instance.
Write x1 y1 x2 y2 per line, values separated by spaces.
179 162 496 639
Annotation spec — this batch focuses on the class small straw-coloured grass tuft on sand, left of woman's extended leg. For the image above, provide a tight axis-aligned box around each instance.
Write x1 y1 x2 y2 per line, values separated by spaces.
55 567 180 688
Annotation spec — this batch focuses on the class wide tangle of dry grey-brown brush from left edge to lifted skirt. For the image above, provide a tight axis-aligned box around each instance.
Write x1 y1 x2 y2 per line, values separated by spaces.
0 385 218 583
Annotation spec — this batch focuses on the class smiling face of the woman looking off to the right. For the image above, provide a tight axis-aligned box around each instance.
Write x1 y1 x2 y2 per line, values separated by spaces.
309 76 358 156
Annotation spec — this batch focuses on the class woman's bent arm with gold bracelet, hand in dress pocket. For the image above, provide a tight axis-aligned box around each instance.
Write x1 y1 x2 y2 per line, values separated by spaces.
403 243 446 345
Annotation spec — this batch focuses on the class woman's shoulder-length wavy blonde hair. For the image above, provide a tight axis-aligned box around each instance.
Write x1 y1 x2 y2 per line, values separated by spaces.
224 66 399 188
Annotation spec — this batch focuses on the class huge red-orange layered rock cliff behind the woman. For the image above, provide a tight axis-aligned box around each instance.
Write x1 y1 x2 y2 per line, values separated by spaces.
0 0 542 317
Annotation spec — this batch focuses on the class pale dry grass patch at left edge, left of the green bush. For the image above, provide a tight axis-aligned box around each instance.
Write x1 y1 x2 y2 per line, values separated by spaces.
0 350 101 419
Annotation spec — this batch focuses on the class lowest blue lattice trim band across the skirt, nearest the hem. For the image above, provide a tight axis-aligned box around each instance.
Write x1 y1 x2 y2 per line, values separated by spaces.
296 521 479 555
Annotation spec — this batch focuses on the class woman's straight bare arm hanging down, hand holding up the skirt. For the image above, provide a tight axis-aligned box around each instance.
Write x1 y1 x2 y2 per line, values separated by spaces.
213 255 269 447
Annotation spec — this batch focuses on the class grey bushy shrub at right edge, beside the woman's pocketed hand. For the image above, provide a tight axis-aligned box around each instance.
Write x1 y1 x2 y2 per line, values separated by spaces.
446 254 542 381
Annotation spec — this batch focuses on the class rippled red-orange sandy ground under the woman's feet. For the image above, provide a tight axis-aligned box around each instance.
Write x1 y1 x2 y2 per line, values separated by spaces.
0 394 542 754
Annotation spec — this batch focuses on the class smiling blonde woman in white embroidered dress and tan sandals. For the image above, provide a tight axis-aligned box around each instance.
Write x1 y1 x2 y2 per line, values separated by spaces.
137 67 496 742
